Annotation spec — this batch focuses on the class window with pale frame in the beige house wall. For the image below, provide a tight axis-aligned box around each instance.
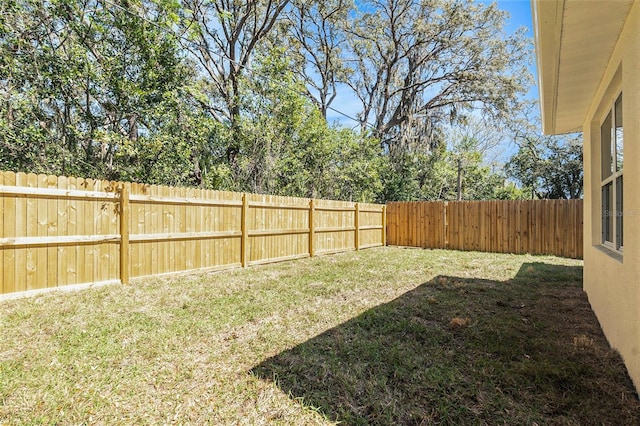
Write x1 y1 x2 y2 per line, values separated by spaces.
600 94 624 251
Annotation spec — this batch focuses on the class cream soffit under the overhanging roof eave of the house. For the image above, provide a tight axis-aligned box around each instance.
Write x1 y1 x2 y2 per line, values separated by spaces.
532 0 633 134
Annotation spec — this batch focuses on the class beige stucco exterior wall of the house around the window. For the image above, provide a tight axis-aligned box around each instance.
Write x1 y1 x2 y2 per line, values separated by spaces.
583 2 640 390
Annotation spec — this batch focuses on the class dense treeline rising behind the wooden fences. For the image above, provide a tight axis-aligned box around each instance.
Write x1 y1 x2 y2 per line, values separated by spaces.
0 0 581 201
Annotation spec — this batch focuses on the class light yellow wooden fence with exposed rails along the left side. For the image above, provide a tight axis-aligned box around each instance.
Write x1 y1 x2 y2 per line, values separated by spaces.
0 172 385 295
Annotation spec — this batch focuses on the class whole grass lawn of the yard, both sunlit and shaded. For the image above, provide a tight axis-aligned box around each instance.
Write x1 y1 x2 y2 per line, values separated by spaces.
0 248 640 425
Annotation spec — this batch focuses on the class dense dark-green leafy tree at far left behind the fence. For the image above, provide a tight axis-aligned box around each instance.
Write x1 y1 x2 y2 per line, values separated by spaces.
0 0 194 179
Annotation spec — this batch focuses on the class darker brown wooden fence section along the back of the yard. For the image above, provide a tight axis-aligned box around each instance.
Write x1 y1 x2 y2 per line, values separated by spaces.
387 200 583 259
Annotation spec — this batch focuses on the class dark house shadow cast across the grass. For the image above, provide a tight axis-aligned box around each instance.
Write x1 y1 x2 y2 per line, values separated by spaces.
251 263 640 425
